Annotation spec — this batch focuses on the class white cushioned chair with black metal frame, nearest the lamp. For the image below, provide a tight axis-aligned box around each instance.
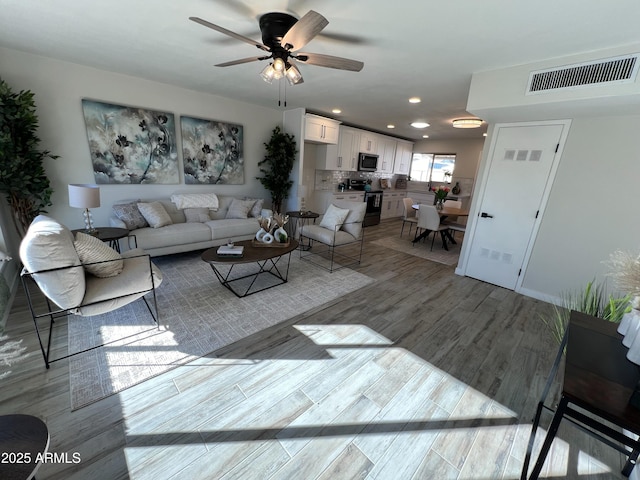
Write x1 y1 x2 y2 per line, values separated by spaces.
20 215 162 368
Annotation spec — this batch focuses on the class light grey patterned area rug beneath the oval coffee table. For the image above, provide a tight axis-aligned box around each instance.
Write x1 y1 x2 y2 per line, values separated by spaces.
68 251 373 409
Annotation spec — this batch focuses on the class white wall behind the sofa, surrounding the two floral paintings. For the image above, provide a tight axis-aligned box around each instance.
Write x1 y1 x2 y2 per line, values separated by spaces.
0 48 282 236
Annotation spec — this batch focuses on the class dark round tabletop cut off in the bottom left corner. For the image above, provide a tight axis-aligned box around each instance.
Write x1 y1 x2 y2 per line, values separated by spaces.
0 415 49 480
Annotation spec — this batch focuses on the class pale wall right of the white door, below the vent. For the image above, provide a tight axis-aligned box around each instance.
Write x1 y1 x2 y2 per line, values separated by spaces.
522 114 640 296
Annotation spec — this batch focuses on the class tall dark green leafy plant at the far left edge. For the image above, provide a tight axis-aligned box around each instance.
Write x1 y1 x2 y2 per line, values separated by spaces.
0 79 58 236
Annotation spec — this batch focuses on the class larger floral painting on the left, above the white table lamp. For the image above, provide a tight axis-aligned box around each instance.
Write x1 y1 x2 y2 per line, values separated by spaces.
82 99 180 184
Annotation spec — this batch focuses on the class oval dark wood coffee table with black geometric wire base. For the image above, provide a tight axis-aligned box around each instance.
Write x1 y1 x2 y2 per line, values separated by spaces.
201 239 298 298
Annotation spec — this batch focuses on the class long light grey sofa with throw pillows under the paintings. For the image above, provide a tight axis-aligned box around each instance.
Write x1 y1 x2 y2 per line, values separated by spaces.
110 194 272 256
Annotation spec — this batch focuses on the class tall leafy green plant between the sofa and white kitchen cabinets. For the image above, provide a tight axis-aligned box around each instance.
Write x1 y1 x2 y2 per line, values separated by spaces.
256 127 298 213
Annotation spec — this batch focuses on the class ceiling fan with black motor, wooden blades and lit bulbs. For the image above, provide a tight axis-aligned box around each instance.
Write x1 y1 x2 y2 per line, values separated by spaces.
189 10 364 85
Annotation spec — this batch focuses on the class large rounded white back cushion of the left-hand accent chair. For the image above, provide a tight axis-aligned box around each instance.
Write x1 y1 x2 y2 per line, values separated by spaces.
20 215 85 308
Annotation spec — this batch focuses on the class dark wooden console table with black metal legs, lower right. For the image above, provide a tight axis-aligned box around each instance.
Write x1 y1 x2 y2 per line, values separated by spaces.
521 312 640 480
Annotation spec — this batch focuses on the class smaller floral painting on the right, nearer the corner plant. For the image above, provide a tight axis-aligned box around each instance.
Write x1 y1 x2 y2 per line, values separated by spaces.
180 117 244 185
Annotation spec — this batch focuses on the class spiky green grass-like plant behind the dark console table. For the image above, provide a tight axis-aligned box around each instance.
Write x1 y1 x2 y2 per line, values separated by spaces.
543 280 631 343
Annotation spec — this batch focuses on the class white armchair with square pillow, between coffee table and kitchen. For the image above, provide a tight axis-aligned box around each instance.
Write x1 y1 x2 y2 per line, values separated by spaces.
300 200 367 272
